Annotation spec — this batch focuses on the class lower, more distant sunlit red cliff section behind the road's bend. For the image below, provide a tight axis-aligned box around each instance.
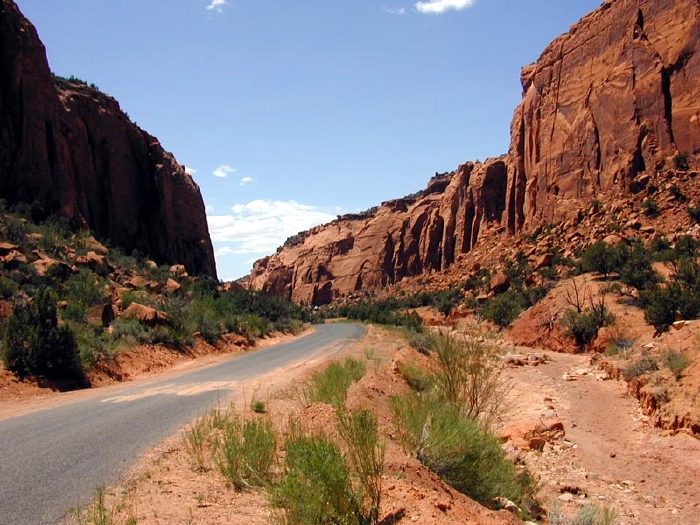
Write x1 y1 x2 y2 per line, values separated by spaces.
249 159 508 304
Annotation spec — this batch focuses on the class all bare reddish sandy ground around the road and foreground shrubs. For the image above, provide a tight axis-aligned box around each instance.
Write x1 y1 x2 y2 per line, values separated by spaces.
0 320 700 525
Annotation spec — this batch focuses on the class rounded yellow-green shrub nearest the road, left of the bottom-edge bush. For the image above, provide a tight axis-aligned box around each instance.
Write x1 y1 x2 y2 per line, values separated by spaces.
214 414 277 490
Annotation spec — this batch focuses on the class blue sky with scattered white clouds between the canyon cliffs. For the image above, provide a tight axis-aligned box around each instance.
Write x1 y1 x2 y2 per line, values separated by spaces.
16 0 600 280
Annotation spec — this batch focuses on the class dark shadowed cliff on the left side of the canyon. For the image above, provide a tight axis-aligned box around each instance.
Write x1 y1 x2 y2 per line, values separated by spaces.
0 0 216 277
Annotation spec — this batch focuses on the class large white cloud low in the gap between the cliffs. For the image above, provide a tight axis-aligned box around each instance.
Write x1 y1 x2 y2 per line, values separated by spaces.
207 200 335 256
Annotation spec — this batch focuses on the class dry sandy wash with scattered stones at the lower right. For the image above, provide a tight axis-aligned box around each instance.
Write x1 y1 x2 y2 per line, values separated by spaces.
504 352 700 525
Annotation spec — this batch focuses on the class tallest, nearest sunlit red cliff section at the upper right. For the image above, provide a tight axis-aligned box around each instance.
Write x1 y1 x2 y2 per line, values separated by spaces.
505 0 700 233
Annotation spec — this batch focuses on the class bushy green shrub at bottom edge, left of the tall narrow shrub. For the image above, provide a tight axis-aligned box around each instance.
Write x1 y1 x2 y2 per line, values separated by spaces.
269 431 358 525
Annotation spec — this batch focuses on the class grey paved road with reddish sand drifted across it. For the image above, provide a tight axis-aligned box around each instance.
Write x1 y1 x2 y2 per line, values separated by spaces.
0 324 364 525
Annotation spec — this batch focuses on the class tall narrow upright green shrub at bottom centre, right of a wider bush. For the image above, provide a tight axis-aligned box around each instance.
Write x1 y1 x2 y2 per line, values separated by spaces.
338 409 384 525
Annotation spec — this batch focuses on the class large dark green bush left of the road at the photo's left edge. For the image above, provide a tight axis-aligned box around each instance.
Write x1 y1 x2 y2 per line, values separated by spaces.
2 289 84 381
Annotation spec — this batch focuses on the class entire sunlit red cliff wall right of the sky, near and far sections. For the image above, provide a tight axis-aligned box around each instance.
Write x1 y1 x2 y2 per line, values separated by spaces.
248 0 700 304
